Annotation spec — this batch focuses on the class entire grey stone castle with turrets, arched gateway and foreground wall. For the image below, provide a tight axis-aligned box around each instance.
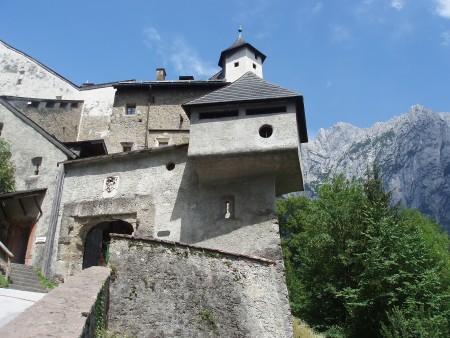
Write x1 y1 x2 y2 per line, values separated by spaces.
0 30 308 337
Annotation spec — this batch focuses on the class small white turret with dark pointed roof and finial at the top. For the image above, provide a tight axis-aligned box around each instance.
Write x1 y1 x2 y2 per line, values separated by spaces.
219 28 266 82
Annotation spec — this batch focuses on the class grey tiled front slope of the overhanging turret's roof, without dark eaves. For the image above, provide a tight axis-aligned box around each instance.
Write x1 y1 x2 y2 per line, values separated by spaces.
183 72 301 108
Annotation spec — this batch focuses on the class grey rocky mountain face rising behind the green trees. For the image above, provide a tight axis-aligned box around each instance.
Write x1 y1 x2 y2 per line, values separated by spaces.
302 105 450 231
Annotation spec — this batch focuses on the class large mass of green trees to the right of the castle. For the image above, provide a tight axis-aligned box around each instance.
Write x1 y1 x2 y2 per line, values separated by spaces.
278 173 450 337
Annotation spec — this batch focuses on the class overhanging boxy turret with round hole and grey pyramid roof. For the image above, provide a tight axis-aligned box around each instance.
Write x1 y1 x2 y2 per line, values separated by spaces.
183 72 308 195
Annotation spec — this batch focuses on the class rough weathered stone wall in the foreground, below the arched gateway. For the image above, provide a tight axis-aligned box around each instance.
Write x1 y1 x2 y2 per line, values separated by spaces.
108 235 292 338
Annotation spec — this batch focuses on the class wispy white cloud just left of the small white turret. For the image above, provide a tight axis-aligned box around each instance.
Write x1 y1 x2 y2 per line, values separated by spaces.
142 27 218 77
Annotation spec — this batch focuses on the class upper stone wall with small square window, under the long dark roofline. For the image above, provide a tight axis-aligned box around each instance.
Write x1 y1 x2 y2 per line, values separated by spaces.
103 85 220 153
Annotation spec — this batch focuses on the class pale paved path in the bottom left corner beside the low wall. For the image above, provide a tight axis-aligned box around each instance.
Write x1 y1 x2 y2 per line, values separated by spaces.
0 288 46 327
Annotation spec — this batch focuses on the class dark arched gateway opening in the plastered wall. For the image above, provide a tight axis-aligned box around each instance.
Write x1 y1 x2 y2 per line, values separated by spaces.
82 220 133 269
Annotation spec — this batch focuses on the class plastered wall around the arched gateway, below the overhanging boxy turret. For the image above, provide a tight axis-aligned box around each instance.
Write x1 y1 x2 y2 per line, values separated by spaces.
54 146 282 275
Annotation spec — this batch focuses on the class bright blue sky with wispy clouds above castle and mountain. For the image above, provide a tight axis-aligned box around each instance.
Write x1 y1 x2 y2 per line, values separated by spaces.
0 0 450 136
